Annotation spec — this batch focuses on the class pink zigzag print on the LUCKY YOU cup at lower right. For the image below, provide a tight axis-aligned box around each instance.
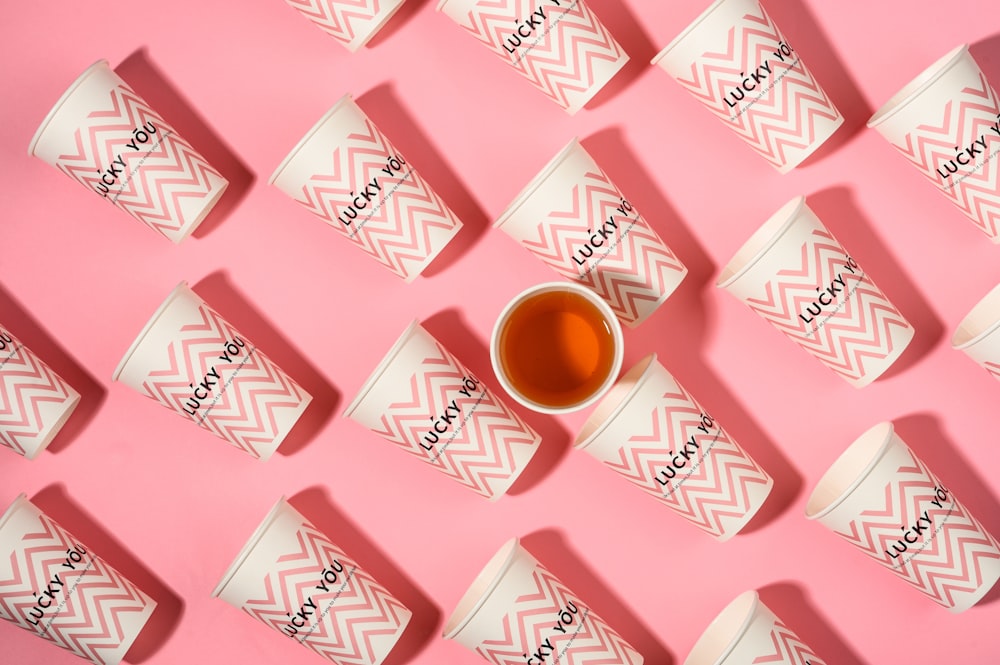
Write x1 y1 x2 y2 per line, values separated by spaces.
836 450 1000 607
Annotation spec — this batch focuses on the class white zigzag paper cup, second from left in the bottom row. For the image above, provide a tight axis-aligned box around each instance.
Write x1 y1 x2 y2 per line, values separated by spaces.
212 498 412 665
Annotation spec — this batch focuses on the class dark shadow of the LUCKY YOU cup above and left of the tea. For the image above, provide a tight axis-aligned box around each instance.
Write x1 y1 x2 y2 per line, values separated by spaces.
357 83 489 277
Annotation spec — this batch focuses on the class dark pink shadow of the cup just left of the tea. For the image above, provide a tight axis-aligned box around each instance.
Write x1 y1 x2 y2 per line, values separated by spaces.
421 309 570 495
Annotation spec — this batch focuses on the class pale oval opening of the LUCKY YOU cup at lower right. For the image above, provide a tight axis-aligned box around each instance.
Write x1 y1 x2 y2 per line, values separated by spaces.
806 422 893 520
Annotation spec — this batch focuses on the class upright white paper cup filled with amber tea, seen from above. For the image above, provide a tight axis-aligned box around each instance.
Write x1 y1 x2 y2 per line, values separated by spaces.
490 282 623 413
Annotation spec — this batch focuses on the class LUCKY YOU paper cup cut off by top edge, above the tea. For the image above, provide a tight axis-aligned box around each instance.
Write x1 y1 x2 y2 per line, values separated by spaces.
437 0 628 115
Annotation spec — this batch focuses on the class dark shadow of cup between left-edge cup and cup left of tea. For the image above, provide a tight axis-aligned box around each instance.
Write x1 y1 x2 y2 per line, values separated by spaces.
193 271 340 456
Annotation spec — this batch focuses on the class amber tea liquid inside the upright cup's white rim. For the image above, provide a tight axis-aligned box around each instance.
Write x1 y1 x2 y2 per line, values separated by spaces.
498 291 615 408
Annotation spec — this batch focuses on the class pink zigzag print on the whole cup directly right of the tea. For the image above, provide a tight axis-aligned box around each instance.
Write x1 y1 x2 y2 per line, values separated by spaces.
746 229 910 381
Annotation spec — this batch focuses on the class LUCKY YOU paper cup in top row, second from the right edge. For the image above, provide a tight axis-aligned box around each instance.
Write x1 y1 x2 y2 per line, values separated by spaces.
653 0 844 173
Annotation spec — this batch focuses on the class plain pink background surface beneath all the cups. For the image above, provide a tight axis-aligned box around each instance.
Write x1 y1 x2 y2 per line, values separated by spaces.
0 0 1000 665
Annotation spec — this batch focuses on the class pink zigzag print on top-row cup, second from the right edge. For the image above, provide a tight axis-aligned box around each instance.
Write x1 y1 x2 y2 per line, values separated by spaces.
676 5 841 168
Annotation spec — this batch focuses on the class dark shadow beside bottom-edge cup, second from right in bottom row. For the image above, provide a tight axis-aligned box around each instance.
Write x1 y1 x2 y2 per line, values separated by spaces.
520 528 676 665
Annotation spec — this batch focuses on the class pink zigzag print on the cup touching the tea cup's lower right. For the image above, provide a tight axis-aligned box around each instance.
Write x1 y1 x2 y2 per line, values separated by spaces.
603 382 770 537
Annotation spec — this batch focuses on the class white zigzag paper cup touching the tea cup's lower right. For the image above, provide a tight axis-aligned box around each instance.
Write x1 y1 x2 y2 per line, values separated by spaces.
574 354 774 541
